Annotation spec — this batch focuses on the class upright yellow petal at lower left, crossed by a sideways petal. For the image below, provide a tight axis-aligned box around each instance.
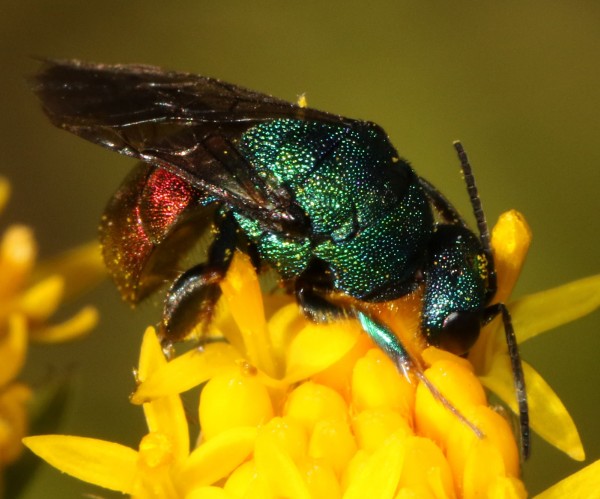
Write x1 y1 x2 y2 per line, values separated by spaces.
137 327 190 461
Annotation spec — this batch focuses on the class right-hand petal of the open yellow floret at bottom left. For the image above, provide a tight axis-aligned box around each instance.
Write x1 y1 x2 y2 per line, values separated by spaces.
177 427 256 490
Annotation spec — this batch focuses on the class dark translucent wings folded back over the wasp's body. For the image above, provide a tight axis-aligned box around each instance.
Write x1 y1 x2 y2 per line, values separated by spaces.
34 61 353 233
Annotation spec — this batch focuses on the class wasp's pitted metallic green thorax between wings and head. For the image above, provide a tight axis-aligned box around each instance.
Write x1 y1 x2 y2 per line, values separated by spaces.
234 119 433 300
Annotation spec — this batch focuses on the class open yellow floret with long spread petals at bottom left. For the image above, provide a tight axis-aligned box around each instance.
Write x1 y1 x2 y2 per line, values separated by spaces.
24 328 257 498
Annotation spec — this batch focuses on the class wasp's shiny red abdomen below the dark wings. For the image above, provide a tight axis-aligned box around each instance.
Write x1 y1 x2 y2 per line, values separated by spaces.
98 163 217 304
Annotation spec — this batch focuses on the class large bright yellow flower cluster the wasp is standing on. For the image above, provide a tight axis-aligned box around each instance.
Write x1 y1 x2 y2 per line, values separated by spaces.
25 212 598 499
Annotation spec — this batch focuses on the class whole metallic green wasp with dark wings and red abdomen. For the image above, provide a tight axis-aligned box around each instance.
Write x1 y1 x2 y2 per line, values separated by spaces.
34 61 529 456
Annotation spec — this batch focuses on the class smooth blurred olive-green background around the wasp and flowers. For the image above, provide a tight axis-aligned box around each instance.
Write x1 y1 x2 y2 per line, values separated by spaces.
0 0 600 498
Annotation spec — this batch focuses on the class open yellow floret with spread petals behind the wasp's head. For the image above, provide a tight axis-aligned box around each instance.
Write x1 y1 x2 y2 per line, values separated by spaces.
469 211 600 461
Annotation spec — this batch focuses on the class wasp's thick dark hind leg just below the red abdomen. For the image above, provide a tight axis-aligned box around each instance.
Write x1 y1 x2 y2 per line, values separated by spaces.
161 212 237 343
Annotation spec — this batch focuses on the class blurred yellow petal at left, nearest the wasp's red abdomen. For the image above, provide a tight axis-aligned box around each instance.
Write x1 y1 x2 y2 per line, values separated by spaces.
33 241 106 299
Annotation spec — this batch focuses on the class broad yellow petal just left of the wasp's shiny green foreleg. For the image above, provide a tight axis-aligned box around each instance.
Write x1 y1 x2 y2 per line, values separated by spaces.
285 321 361 384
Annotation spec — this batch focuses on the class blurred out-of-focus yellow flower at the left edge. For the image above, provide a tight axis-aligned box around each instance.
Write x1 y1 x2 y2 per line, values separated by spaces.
0 177 104 466
